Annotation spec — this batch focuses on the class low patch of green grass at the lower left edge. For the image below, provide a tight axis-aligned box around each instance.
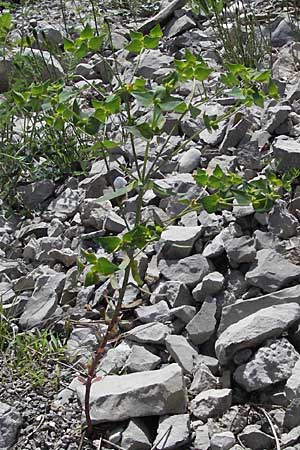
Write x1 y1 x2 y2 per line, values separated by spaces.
0 305 64 387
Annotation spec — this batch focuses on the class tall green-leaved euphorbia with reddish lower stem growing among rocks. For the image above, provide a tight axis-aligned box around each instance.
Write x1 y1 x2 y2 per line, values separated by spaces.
69 26 293 432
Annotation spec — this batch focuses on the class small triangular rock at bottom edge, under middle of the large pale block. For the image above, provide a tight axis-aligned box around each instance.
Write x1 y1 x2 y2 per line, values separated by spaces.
121 419 152 450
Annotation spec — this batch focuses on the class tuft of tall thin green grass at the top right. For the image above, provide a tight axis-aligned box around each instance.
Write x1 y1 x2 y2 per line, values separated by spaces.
192 0 270 68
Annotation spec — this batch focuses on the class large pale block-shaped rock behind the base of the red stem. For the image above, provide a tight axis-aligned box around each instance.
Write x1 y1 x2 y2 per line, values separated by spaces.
76 364 187 423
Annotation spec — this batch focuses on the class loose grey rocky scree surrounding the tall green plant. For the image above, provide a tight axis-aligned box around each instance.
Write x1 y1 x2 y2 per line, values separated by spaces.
0 1 300 450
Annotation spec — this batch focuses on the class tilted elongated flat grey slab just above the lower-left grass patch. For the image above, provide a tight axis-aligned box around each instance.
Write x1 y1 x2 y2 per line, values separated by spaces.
19 273 66 330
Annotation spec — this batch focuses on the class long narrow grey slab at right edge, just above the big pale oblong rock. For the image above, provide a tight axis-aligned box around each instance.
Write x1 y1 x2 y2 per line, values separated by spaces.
219 285 300 333
